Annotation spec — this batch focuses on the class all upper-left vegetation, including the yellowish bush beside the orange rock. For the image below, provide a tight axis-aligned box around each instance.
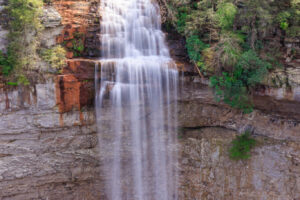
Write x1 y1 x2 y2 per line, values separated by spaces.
0 0 65 85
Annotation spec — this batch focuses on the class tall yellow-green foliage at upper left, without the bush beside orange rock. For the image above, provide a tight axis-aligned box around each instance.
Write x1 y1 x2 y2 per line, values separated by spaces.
1 0 43 85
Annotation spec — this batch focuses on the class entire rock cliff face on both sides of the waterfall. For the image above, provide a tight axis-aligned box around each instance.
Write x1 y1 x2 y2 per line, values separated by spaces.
0 1 300 200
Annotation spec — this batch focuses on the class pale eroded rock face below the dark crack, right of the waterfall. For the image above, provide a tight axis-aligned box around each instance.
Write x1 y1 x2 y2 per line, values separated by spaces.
179 128 300 200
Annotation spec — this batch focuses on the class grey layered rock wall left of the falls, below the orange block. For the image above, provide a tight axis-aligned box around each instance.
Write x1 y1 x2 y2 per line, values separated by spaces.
0 80 101 200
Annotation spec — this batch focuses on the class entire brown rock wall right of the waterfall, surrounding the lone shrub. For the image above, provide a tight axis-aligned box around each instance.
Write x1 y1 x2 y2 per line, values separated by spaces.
159 7 300 197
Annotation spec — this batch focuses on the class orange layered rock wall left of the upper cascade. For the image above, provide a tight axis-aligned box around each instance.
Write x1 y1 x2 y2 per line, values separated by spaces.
53 0 100 58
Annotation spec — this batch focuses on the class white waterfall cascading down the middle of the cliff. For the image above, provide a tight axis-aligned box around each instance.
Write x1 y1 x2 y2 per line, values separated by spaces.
95 0 178 200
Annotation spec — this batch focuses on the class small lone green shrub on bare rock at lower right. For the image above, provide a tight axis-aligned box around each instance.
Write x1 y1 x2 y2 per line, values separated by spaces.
229 131 256 160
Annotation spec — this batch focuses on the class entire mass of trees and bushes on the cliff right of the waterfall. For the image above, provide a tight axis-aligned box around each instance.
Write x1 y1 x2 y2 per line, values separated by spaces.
167 0 300 113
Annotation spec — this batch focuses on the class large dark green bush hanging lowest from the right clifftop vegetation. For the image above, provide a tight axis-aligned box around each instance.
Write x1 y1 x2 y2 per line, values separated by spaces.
210 50 272 113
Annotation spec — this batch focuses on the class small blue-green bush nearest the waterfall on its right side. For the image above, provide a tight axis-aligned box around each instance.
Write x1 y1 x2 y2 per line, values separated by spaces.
186 35 209 63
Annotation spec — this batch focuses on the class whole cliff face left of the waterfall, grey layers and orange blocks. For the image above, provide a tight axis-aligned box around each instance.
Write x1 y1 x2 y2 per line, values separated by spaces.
0 1 103 200
